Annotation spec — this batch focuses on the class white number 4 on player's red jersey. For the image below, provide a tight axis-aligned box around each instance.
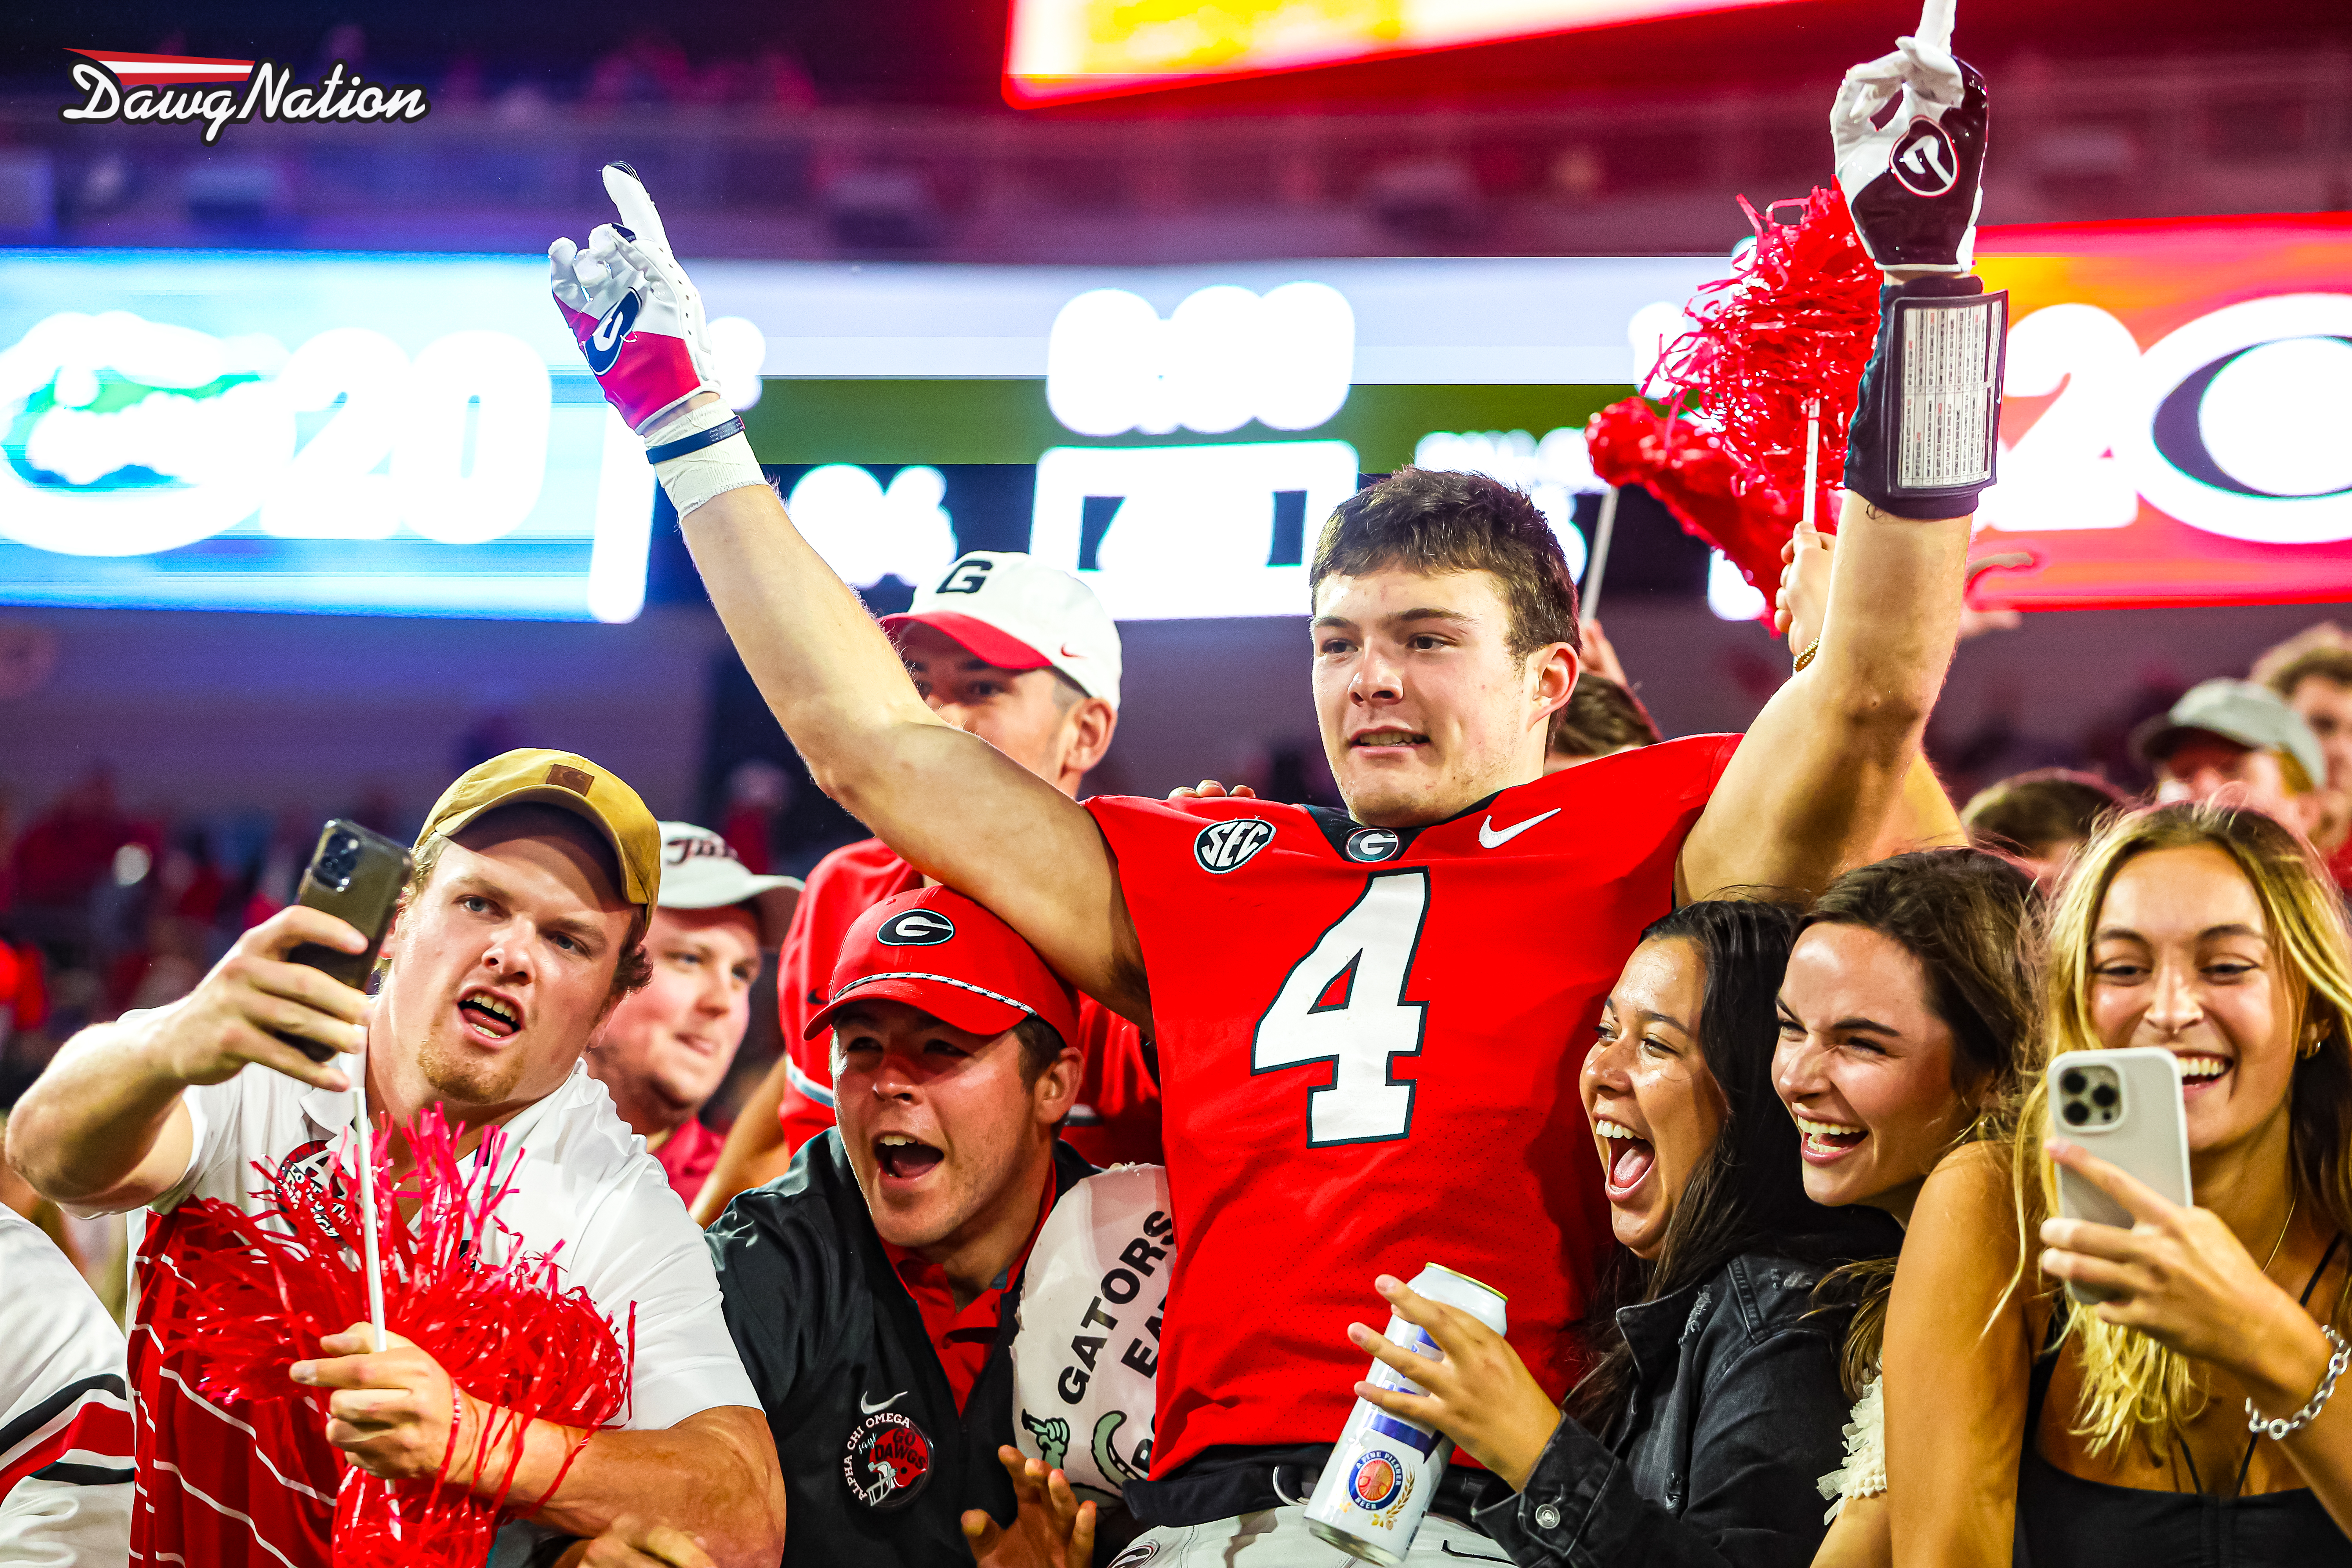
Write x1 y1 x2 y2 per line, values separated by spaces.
1249 870 1430 1147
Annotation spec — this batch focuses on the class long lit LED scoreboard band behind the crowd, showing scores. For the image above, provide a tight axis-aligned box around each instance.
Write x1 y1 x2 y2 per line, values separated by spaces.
0 216 2352 621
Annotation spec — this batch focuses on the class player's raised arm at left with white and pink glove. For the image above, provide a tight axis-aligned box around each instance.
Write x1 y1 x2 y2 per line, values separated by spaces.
548 165 1148 1023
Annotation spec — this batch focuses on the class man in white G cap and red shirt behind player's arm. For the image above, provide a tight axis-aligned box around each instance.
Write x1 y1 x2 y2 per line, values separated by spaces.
691 550 1160 1225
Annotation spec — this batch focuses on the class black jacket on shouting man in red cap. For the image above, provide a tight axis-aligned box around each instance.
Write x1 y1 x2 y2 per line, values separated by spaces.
706 1131 1094 1568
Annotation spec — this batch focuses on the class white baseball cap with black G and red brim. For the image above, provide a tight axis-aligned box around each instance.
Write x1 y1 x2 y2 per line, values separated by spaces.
882 550 1120 708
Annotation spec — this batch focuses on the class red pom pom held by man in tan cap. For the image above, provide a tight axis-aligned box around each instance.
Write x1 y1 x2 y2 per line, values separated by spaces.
148 1110 635 1568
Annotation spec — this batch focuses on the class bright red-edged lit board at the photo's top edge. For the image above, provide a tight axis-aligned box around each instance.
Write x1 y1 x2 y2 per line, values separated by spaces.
1004 0 1785 108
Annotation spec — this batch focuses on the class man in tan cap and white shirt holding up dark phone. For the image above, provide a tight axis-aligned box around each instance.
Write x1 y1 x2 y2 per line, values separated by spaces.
7 750 783 1568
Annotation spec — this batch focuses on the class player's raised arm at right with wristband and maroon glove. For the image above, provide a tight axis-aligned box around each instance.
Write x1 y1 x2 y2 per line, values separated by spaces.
1677 12 2006 898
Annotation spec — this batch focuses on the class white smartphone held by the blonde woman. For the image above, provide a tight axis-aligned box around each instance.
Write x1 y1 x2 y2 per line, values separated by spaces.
2049 1046 2197 1305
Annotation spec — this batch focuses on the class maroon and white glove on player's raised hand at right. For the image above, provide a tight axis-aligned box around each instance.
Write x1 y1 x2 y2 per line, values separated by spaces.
1830 0 1985 273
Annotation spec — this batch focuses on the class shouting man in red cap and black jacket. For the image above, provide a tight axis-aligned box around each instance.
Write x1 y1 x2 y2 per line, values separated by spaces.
708 889 1115 1566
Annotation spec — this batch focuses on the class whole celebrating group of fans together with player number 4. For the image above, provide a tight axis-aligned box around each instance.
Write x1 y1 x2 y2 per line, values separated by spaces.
14 34 2352 1568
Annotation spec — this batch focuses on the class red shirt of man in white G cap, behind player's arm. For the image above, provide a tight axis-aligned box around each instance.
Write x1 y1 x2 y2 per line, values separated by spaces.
776 839 1160 1166
